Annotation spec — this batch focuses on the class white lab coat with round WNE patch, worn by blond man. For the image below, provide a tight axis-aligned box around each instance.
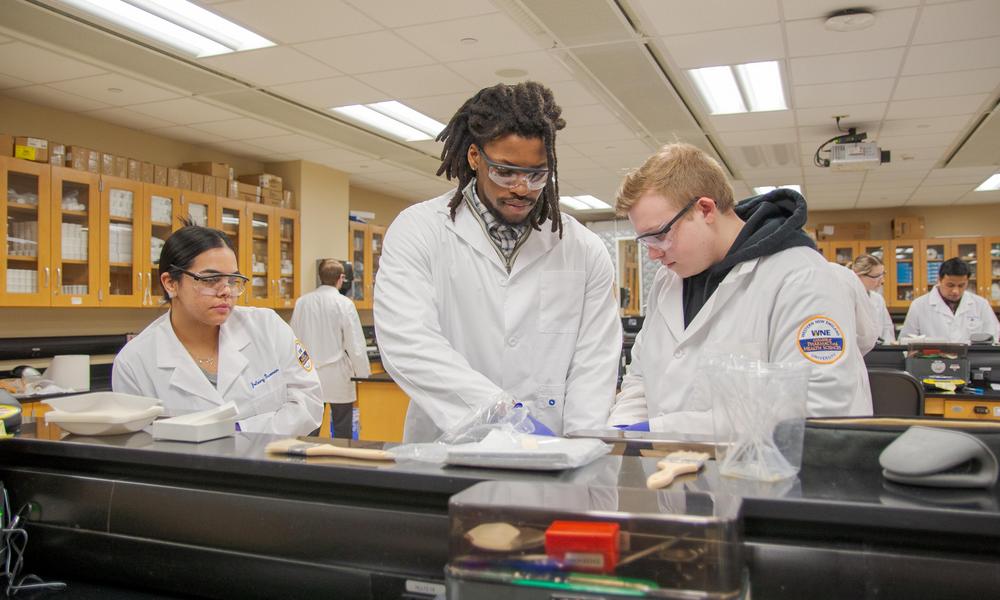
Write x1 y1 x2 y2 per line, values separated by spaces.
608 247 872 435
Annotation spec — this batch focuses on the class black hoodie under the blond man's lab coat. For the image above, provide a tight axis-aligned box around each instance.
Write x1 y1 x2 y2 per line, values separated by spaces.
684 188 816 327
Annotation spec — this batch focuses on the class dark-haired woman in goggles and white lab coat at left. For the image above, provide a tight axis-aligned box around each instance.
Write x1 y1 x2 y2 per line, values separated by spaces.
111 226 323 435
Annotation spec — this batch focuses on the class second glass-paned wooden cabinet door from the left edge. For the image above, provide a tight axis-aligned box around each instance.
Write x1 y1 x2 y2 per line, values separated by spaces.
50 167 101 306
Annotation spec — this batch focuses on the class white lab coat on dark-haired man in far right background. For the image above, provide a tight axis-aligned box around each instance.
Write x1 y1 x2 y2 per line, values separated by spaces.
899 286 1000 342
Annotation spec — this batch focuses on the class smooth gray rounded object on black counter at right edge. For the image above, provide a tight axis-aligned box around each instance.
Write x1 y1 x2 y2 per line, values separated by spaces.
879 427 1000 488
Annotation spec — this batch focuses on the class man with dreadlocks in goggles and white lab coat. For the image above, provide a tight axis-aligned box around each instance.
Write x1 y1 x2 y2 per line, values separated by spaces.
375 82 621 442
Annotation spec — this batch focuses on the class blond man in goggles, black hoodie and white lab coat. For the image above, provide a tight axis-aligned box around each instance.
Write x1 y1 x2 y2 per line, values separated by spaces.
608 143 872 435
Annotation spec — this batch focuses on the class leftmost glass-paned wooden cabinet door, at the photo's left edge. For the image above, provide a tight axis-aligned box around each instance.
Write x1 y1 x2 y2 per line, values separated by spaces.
0 156 53 306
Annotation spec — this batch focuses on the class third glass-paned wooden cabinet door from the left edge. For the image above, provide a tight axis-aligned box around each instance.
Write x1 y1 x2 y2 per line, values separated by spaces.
98 177 149 306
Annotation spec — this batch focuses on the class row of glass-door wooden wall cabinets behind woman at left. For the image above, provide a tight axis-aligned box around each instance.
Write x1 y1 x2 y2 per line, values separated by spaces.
0 157 301 308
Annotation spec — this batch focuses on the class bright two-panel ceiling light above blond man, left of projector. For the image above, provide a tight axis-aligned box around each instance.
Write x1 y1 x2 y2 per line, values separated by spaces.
688 60 788 115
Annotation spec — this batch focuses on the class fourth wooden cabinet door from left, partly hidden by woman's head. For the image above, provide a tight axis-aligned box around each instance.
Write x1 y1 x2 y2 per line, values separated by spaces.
140 183 181 307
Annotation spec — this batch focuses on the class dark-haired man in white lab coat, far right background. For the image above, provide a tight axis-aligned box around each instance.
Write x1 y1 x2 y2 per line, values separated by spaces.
899 258 1000 342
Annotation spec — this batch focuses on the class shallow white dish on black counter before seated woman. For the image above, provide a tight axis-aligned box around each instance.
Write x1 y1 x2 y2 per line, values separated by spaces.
44 392 163 435
